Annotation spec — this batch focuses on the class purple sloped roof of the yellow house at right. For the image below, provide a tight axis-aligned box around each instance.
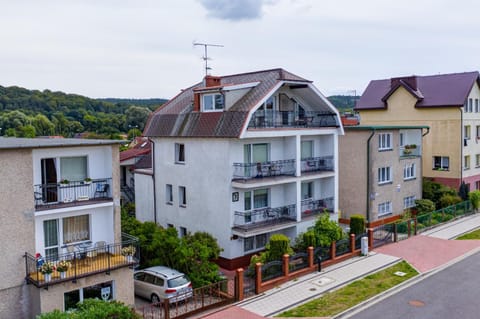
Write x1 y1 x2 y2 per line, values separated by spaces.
355 71 480 111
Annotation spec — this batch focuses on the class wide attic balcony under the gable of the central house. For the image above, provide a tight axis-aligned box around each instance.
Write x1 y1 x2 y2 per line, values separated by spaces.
248 110 340 129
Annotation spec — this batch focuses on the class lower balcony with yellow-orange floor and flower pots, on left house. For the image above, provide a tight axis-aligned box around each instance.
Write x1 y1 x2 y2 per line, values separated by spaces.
24 234 140 288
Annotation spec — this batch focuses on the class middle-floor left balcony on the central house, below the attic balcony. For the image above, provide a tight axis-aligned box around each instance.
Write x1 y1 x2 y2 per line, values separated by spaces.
233 159 295 180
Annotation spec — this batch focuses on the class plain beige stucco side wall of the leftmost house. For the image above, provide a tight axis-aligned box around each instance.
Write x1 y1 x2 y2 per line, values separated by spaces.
0 150 35 318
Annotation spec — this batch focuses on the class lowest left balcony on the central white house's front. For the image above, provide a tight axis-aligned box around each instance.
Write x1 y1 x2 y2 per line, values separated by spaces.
233 204 297 232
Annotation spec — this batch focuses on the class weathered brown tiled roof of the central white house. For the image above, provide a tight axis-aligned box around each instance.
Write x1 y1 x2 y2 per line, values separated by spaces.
143 69 310 137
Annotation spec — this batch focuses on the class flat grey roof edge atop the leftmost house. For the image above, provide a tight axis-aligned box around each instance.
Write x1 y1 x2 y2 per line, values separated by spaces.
0 137 125 149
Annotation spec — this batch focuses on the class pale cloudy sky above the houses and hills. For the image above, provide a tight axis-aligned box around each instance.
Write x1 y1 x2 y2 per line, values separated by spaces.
0 0 480 99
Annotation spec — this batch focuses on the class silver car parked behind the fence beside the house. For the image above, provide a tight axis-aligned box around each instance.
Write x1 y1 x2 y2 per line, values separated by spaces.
133 266 193 303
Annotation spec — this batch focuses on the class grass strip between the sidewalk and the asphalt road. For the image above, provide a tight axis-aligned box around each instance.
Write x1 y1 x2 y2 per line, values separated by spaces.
277 261 418 317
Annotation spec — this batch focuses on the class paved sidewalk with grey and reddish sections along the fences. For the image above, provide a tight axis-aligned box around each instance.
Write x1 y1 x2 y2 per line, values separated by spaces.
204 214 480 319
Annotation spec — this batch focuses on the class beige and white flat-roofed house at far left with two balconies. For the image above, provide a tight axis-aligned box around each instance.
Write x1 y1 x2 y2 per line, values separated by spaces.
0 138 138 318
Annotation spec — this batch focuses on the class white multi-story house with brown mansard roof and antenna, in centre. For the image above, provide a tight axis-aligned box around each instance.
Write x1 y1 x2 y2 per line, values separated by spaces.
142 69 343 269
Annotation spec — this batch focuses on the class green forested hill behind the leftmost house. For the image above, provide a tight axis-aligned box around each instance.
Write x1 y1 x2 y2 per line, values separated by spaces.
0 86 166 138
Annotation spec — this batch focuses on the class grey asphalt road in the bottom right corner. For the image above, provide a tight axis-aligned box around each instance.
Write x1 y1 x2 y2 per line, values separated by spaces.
349 252 480 319
